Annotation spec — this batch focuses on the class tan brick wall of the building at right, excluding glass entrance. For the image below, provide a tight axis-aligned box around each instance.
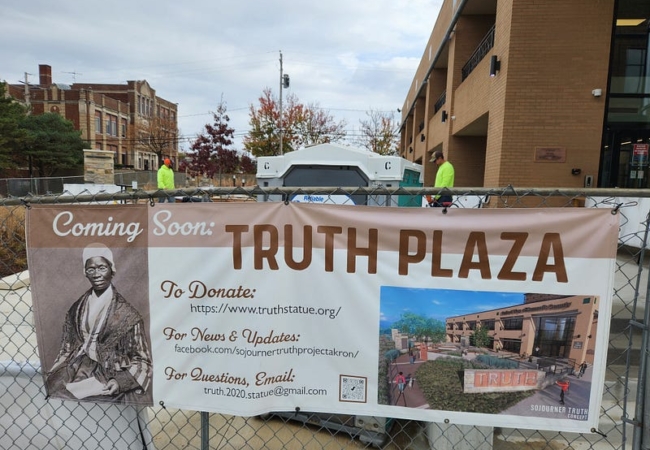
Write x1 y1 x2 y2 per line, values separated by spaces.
402 0 614 187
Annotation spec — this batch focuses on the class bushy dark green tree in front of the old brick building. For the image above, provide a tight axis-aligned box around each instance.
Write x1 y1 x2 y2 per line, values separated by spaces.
18 113 85 177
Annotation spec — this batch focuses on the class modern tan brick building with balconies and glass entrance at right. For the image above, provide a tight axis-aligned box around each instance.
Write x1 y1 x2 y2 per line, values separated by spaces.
400 0 650 188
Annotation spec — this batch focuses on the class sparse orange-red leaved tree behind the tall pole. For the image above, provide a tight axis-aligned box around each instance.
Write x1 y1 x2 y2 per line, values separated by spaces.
244 88 345 157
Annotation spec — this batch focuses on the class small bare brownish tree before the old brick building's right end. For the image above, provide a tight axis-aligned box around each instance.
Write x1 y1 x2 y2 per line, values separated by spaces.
134 115 178 162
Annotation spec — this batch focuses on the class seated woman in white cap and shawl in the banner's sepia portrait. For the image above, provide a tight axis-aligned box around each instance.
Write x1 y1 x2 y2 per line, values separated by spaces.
45 244 152 405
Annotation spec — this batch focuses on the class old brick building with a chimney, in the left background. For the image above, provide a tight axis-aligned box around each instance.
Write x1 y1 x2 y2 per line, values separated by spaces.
8 64 178 170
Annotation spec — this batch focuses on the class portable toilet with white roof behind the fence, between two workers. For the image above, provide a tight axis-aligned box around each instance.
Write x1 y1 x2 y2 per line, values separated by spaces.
257 143 422 207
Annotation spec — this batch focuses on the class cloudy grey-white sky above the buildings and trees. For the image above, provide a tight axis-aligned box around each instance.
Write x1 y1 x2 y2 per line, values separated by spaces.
0 0 442 153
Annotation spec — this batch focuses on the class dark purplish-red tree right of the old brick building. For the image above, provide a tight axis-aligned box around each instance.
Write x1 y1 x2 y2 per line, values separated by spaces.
180 100 240 183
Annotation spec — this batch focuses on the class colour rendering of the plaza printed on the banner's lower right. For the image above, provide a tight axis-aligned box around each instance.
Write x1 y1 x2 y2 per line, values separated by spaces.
380 286 599 420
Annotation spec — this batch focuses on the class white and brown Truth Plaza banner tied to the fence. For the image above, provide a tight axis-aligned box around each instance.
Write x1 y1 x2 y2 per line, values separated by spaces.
27 202 619 432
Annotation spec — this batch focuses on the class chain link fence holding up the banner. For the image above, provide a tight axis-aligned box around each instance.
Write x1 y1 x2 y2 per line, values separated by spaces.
0 187 650 450
